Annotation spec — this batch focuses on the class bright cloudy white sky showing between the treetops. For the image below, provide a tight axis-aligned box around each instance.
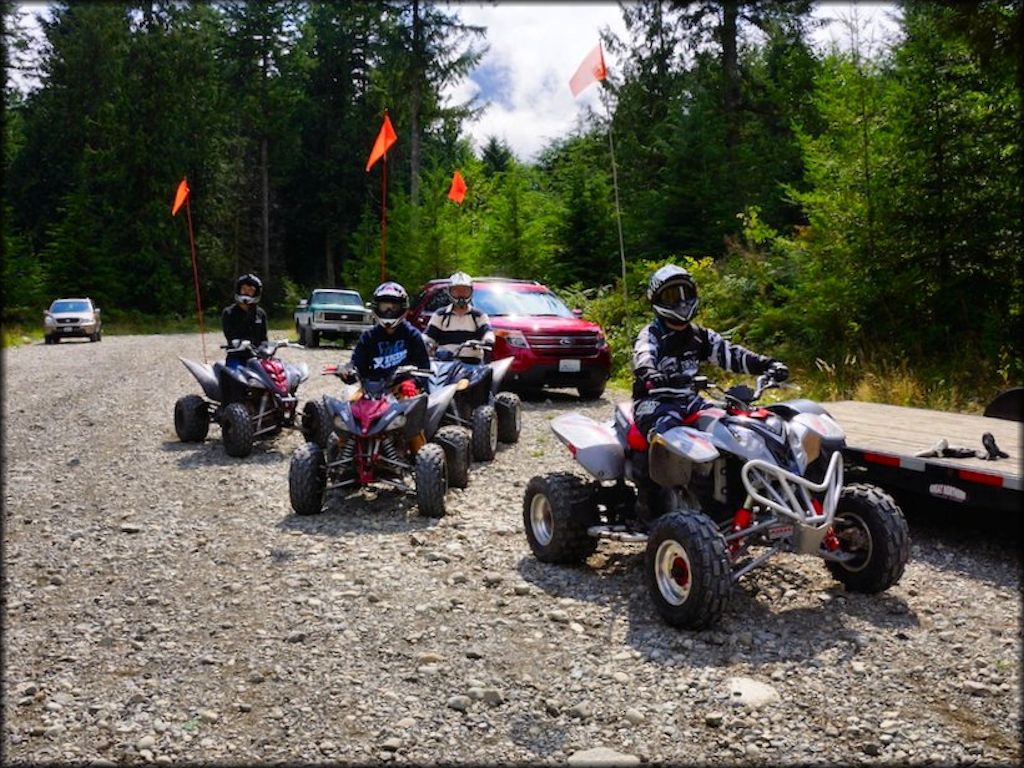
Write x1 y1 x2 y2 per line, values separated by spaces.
9 1 895 161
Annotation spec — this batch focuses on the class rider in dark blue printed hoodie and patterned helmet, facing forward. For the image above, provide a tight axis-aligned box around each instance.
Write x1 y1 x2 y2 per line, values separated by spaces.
343 282 430 387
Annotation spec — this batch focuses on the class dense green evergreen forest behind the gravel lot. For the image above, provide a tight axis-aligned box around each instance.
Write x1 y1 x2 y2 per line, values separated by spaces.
2 0 1024 404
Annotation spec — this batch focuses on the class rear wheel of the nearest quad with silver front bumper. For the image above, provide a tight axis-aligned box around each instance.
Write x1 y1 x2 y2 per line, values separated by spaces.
522 472 599 564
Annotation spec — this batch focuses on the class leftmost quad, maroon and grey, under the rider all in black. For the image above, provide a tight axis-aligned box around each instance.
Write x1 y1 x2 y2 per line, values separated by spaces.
174 340 309 458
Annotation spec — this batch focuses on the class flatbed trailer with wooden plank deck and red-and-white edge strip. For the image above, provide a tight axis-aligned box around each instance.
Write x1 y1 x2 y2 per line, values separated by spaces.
822 400 1024 513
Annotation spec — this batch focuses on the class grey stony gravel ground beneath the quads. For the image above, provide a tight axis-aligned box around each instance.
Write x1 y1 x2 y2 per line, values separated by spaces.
2 334 1022 765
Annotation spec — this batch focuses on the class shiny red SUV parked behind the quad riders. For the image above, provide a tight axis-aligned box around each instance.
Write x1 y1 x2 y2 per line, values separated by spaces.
407 278 611 399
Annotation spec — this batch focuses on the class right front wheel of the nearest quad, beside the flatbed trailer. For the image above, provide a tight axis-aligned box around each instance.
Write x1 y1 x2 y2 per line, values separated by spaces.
825 483 910 593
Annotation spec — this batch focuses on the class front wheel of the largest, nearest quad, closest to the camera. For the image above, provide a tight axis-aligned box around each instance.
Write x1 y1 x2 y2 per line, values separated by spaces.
644 512 732 630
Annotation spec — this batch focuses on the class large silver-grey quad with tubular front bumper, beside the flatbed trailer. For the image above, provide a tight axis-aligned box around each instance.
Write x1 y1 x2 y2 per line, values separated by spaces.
523 373 910 629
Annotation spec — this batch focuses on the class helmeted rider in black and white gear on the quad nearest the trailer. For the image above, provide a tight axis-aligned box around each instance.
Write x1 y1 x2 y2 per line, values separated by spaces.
633 264 790 521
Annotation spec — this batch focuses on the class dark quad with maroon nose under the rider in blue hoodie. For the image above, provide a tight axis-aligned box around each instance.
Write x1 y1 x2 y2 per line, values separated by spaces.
288 366 469 517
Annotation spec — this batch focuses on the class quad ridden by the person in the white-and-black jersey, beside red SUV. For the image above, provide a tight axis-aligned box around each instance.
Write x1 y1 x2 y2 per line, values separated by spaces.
427 340 522 461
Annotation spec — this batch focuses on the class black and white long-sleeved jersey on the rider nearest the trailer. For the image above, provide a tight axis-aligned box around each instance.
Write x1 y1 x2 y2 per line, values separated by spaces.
633 317 774 399
